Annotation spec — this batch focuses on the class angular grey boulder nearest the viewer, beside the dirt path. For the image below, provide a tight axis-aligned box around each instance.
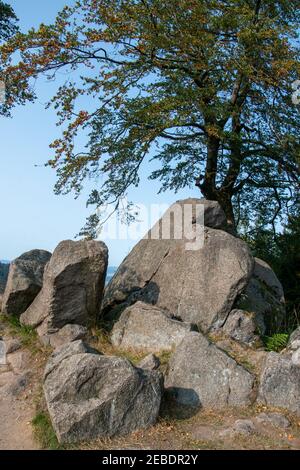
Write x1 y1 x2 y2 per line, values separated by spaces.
44 341 163 443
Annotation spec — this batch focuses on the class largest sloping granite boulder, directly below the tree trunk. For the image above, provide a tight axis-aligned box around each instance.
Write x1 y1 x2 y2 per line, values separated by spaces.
102 200 254 332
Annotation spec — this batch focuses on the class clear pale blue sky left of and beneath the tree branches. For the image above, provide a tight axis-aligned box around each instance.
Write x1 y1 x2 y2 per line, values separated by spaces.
0 0 198 265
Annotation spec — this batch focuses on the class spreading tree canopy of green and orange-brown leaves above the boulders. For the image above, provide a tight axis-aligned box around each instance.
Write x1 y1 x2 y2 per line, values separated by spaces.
0 0 300 230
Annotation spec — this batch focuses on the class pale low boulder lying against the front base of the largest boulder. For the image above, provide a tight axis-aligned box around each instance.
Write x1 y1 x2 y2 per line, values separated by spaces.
111 302 194 352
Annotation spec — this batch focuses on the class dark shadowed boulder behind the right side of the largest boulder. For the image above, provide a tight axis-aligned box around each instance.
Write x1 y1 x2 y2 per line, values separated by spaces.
236 258 286 335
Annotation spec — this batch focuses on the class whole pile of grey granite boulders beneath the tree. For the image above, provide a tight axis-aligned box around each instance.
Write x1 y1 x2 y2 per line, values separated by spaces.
0 199 300 443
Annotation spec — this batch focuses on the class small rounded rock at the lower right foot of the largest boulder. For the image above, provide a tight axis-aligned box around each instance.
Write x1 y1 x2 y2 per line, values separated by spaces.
222 310 258 345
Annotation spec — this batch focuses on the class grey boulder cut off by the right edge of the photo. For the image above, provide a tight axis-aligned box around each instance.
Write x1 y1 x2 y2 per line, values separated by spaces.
258 352 300 415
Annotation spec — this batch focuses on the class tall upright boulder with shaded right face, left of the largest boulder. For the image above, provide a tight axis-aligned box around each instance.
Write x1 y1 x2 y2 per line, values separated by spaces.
21 240 108 330
